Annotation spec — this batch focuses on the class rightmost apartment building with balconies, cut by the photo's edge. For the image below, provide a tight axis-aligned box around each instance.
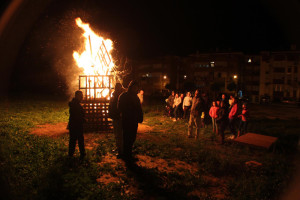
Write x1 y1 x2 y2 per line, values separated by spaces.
259 51 300 101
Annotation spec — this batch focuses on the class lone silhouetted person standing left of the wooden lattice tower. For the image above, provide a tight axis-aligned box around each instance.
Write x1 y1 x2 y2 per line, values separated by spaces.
68 90 85 159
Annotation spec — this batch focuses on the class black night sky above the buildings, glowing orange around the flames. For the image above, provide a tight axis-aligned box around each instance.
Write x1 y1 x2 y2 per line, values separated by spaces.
0 0 300 94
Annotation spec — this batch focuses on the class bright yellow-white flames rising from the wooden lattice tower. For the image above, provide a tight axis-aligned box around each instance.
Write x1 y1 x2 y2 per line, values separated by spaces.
73 18 114 98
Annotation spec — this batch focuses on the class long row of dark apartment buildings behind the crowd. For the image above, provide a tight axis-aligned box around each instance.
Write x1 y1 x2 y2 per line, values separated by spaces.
135 51 300 103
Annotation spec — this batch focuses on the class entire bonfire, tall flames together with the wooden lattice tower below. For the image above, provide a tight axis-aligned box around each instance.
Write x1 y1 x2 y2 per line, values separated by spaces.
73 18 116 132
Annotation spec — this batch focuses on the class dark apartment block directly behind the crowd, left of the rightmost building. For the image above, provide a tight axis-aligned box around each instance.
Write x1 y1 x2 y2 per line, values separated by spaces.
185 52 244 93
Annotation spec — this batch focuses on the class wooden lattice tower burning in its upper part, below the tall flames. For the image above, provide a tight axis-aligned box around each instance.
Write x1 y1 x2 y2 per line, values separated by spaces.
79 75 114 132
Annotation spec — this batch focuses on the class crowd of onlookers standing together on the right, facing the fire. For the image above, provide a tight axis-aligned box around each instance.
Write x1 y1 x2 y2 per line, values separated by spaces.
165 90 249 144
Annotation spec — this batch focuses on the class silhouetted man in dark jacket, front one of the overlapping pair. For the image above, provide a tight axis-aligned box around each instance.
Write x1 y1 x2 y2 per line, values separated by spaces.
118 81 143 162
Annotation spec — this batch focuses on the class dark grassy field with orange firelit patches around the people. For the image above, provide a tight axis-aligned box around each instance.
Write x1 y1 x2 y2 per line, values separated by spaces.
0 96 300 199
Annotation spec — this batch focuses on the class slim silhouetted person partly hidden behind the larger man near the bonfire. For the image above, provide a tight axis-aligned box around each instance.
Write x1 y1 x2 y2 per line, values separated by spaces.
108 83 124 158
